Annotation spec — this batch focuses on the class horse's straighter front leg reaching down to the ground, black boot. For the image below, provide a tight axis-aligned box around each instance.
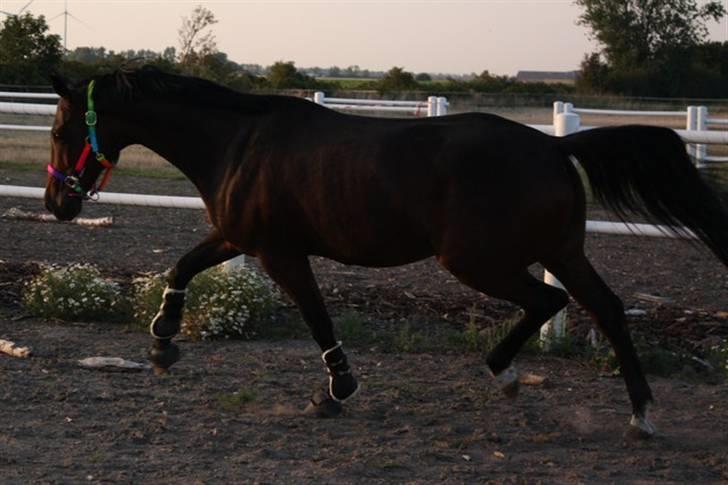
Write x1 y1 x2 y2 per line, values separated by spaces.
258 254 359 404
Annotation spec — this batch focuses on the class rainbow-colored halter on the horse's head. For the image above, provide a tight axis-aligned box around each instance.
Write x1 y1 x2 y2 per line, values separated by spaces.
48 80 114 200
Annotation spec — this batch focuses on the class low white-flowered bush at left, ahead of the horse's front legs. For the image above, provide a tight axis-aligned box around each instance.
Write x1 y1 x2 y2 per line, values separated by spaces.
23 264 124 321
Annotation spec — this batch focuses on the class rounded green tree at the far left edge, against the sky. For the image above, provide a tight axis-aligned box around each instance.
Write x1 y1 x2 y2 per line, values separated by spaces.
0 13 63 84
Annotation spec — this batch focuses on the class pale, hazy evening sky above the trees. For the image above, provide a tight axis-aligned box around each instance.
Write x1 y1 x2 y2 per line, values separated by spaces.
0 0 728 75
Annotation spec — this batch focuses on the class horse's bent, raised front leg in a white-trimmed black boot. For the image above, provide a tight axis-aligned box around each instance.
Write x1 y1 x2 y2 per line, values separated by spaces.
149 229 240 374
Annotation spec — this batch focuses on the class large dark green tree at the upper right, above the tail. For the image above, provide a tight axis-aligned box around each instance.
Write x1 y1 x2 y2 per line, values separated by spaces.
575 0 725 96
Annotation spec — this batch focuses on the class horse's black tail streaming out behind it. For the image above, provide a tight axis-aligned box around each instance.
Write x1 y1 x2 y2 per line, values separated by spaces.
559 125 728 266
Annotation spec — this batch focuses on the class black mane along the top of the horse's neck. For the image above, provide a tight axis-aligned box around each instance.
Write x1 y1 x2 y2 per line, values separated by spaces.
83 66 283 112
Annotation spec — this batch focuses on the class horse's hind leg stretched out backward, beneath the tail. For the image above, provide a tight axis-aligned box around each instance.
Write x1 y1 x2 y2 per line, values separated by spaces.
545 253 655 437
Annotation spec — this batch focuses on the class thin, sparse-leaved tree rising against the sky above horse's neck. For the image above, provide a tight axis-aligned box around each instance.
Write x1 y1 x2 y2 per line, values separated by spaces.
177 5 217 70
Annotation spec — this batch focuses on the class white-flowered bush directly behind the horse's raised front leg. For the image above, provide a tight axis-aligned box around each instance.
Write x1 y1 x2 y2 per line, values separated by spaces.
133 267 279 339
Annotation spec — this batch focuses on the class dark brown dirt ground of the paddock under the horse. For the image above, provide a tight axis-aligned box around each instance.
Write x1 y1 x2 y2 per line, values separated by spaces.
0 167 728 484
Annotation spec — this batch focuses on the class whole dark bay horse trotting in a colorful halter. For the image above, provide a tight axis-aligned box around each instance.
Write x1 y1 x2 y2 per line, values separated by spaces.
45 68 728 435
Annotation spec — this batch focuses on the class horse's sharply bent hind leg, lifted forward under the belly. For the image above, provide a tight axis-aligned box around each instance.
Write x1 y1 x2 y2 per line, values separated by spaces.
438 257 569 397
